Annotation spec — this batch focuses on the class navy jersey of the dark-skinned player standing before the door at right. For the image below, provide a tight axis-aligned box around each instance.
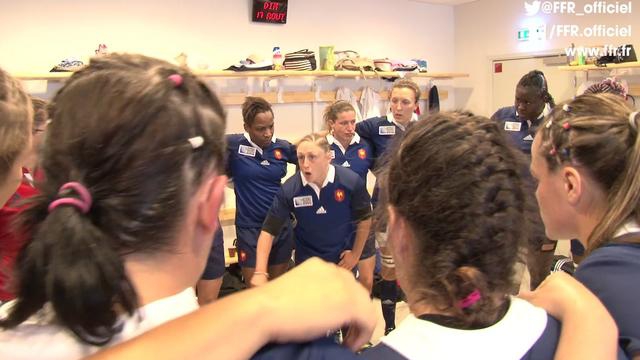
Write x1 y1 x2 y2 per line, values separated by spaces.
491 106 544 156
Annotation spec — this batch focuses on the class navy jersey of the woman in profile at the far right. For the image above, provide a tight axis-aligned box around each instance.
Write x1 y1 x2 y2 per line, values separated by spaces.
575 233 640 355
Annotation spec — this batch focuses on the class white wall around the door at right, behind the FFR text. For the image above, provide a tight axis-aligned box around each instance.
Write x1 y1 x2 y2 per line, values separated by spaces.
454 0 640 116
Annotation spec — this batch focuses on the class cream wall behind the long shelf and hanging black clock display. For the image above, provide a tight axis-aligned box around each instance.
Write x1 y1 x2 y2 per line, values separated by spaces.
0 0 456 137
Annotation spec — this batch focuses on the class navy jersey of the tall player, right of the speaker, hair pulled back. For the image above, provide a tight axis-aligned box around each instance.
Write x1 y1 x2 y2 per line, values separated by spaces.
356 116 404 167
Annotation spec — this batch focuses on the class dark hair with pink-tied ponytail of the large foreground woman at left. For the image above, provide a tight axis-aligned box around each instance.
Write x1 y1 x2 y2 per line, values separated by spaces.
0 54 225 345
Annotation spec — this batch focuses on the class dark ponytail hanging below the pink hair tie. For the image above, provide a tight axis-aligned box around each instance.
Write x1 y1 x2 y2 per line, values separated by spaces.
0 196 138 345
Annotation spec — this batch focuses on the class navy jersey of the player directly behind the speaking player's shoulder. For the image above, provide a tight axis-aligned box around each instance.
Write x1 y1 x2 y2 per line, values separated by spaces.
327 134 373 184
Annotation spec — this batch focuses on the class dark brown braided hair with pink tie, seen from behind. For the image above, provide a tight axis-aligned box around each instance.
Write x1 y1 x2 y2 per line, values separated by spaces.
382 112 529 328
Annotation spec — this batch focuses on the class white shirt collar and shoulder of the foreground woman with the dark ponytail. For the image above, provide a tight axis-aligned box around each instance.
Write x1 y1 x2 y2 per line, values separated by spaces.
0 288 198 360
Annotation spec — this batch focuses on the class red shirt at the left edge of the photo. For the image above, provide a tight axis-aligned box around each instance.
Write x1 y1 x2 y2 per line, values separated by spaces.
0 171 38 301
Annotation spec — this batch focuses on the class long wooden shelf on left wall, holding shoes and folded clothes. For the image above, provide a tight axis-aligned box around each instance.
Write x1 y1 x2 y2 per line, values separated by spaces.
14 70 469 80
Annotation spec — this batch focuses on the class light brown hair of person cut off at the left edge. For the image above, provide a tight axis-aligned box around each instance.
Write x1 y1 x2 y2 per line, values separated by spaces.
0 69 33 183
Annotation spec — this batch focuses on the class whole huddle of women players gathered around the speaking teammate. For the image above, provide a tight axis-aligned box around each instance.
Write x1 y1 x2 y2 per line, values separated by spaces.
0 54 640 359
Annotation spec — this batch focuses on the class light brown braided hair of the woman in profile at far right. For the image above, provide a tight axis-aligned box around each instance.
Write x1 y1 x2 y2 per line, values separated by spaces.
538 94 640 252
